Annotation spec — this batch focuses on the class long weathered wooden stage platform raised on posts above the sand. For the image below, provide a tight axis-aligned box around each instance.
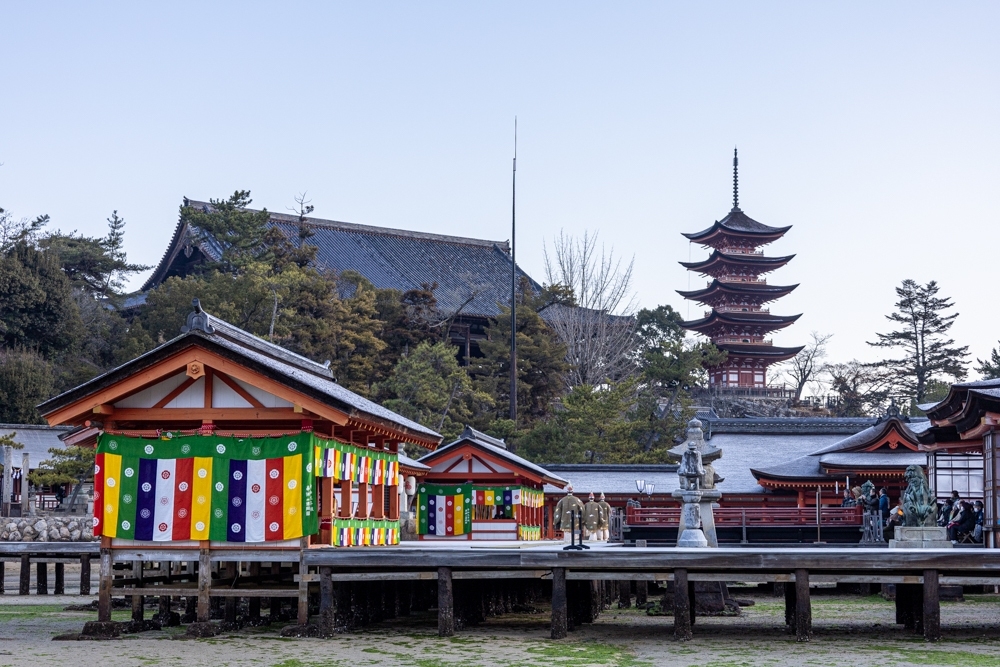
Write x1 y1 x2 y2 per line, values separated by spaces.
0 542 1000 640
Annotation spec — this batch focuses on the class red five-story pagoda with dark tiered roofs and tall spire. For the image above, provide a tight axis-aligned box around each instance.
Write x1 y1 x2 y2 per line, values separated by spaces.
677 151 802 389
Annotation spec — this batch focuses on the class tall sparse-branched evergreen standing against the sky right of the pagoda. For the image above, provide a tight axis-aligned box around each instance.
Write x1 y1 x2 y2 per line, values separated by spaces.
868 279 969 404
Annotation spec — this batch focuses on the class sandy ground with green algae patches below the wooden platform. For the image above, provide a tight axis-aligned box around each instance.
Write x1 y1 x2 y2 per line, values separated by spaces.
0 593 1000 667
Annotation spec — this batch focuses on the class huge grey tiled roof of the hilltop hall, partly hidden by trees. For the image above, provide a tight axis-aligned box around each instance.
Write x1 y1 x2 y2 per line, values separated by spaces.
142 200 541 317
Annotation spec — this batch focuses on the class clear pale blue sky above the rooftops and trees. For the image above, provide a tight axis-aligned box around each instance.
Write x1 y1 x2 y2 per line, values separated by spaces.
0 2 1000 377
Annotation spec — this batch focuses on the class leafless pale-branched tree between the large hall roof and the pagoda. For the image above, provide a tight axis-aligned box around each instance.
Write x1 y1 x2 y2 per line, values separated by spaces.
545 232 637 386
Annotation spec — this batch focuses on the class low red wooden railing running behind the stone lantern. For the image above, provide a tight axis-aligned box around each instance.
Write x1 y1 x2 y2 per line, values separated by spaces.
625 507 862 528
